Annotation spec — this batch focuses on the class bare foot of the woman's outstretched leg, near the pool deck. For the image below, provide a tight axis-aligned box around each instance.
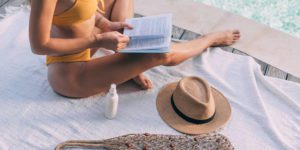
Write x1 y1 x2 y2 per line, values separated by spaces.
205 30 240 46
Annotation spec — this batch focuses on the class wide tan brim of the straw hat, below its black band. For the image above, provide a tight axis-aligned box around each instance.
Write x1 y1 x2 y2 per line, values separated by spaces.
156 82 231 135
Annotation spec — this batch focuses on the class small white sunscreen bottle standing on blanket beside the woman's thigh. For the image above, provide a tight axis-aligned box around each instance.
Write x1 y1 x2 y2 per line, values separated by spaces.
105 84 119 119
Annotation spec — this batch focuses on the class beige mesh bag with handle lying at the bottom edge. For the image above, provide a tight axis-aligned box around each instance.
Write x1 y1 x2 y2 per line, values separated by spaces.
55 133 234 150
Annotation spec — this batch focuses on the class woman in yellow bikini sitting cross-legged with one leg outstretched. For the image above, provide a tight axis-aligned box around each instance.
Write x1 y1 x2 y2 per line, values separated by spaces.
29 0 240 98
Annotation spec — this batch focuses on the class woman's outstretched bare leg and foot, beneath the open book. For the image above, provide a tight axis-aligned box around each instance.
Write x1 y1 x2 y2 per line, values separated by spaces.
76 31 239 97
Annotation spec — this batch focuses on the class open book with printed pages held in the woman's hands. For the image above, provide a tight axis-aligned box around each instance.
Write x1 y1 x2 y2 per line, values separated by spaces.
120 14 172 53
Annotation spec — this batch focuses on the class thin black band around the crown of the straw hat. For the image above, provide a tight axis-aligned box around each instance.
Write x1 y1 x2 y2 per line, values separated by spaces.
171 94 216 124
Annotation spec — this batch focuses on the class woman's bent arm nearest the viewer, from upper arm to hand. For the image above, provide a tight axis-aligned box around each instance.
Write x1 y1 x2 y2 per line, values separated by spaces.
29 0 129 55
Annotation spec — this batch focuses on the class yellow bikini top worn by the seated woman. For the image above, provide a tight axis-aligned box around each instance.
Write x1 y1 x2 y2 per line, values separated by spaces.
53 0 104 26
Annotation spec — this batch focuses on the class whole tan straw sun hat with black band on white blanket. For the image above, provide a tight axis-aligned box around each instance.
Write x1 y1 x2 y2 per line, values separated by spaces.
156 77 231 135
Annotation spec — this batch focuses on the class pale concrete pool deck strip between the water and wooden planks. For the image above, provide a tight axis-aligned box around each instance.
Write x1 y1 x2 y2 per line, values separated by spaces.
135 0 300 81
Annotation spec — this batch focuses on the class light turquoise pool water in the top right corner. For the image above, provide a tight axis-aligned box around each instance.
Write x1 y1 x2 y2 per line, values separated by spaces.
194 0 300 37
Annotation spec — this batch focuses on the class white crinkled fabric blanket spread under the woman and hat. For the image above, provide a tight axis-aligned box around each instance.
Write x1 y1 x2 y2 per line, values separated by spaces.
0 8 300 150
